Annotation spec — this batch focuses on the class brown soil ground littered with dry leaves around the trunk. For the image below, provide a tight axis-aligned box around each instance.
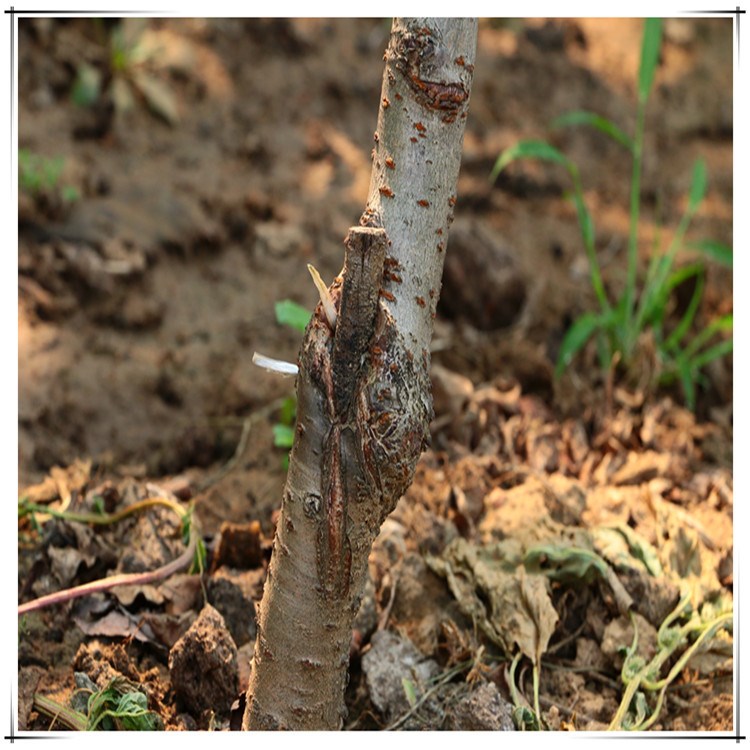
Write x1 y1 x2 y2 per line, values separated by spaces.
18 18 733 731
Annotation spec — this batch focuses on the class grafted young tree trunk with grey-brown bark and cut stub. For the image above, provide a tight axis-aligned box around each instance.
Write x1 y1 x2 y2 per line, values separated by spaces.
243 18 477 730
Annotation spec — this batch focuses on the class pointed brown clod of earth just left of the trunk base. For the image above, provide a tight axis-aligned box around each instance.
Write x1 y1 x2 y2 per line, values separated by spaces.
169 604 239 715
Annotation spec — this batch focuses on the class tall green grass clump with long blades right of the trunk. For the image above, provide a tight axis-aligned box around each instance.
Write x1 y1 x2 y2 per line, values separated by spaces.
490 19 733 409
